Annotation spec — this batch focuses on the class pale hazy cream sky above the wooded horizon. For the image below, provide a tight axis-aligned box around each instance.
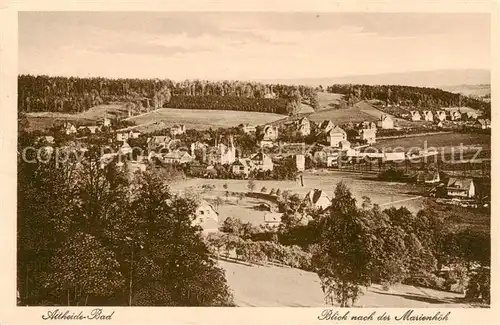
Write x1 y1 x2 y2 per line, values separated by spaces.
18 12 491 80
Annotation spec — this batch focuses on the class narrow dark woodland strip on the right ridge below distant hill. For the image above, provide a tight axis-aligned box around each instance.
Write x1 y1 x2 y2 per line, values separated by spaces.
327 85 491 114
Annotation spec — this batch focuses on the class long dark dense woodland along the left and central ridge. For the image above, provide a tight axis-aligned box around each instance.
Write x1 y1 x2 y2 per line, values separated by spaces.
18 75 315 114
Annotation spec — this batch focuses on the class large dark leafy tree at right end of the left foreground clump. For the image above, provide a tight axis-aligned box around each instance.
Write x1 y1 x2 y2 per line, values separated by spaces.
127 173 232 306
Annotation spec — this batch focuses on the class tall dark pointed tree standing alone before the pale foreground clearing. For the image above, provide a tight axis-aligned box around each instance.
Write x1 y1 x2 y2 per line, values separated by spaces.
313 183 374 307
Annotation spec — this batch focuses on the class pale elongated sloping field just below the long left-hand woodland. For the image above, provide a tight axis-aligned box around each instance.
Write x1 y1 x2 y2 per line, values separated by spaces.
128 108 284 132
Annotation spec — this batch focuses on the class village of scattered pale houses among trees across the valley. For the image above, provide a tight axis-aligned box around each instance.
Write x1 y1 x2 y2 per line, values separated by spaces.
32 105 491 232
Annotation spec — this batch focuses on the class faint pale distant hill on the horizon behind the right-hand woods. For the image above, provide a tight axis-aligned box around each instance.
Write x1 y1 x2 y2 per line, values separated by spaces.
259 69 490 87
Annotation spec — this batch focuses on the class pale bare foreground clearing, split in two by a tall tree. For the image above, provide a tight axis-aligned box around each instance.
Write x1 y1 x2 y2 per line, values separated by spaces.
219 261 469 306
